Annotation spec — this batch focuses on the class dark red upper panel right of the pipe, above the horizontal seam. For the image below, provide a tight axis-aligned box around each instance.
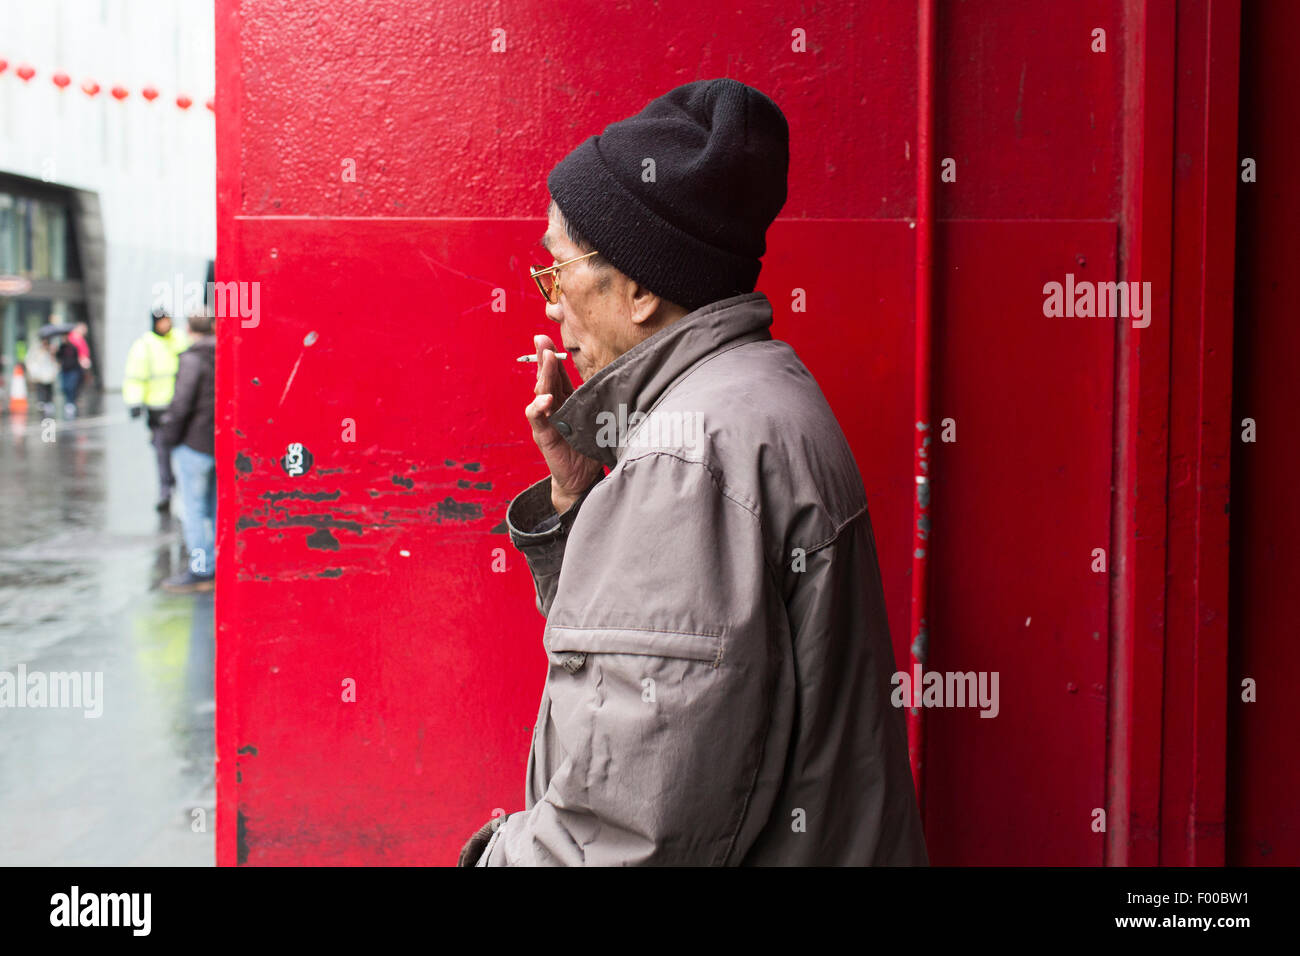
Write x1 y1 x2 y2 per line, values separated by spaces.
935 0 1126 219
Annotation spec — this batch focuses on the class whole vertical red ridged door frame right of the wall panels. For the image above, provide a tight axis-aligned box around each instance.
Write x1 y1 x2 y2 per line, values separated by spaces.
1105 0 1240 866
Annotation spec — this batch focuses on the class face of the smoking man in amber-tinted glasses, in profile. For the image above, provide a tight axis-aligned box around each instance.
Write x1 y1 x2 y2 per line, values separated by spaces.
543 209 644 381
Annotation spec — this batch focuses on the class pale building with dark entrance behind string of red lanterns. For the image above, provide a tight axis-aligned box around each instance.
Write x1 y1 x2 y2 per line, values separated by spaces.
0 0 216 389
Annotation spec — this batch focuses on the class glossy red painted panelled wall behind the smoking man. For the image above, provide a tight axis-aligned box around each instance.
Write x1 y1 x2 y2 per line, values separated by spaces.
217 0 1296 864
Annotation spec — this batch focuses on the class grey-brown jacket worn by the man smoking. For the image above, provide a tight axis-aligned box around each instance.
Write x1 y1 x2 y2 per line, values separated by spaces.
477 293 928 866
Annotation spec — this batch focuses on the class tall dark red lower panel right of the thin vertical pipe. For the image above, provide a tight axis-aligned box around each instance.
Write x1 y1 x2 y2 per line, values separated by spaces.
926 221 1115 865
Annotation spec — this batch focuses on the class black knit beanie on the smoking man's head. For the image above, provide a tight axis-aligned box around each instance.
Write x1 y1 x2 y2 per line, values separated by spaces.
546 79 790 311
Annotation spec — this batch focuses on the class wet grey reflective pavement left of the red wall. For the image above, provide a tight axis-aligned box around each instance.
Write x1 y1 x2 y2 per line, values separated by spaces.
0 395 216 866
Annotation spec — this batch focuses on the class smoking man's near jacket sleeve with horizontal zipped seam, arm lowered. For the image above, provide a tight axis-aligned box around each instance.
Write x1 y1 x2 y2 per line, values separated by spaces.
478 451 774 866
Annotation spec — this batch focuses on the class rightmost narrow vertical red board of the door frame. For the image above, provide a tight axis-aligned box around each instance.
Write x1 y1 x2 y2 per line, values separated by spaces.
1160 1 1239 866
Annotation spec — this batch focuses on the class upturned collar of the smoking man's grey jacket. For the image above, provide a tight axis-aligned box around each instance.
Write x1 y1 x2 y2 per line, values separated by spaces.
551 291 772 468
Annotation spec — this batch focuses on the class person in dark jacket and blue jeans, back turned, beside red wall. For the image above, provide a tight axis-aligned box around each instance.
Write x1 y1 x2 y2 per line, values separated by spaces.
163 315 217 593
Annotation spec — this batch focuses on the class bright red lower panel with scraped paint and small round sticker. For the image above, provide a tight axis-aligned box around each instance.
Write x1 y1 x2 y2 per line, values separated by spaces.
218 219 547 864
